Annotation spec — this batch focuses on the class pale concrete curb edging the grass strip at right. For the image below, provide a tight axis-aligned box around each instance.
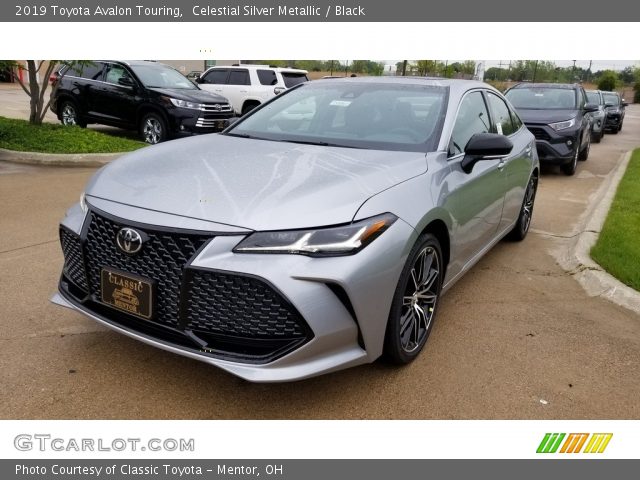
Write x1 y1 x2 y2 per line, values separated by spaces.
556 152 640 314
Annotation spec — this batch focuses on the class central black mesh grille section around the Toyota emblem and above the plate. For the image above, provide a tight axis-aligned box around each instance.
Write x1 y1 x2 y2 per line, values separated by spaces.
85 211 211 328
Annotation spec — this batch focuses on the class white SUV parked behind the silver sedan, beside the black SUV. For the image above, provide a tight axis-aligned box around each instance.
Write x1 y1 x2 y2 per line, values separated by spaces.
196 64 309 115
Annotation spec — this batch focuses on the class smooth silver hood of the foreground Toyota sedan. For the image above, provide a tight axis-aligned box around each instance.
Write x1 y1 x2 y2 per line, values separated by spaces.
86 134 427 230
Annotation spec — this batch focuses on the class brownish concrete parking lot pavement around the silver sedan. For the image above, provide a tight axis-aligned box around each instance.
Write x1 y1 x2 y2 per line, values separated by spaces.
0 92 640 419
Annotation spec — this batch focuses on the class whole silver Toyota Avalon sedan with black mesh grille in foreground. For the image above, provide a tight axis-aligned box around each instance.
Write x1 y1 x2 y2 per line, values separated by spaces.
53 77 539 382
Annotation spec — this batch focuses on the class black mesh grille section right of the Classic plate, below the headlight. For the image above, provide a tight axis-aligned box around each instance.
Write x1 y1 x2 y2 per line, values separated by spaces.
186 270 306 340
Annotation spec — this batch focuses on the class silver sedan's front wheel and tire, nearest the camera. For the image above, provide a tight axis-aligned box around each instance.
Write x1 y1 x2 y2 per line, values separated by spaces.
383 233 445 365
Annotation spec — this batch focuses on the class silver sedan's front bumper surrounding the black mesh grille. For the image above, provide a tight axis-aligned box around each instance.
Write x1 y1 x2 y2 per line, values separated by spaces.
52 199 417 382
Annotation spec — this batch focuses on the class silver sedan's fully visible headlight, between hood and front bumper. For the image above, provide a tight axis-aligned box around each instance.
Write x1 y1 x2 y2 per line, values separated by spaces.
233 213 397 257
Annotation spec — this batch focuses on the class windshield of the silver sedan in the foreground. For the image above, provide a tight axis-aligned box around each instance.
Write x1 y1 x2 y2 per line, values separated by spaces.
226 81 448 152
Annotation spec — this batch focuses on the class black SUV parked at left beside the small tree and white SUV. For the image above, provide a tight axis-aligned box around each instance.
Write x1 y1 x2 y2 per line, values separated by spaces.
51 61 234 143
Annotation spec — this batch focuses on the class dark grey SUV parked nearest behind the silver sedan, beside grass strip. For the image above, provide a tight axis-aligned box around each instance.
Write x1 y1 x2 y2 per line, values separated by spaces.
505 83 598 175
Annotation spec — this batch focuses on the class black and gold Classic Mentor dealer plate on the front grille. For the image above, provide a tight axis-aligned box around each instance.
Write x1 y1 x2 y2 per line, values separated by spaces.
100 267 153 319
